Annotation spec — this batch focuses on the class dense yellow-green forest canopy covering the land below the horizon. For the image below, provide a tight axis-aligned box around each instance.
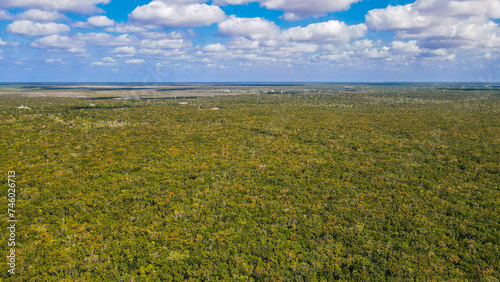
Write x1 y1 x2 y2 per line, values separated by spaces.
0 88 500 281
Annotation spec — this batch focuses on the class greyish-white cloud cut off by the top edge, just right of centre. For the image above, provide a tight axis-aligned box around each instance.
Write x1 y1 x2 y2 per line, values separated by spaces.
213 0 360 20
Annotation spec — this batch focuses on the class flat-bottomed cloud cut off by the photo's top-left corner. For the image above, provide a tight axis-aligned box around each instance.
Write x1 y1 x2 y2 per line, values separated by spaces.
0 0 111 14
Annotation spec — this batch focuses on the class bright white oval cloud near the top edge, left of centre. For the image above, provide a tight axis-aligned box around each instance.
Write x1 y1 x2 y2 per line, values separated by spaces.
129 0 226 27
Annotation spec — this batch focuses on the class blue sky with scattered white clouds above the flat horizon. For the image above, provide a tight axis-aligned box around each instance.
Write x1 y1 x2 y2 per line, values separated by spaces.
0 0 500 83
